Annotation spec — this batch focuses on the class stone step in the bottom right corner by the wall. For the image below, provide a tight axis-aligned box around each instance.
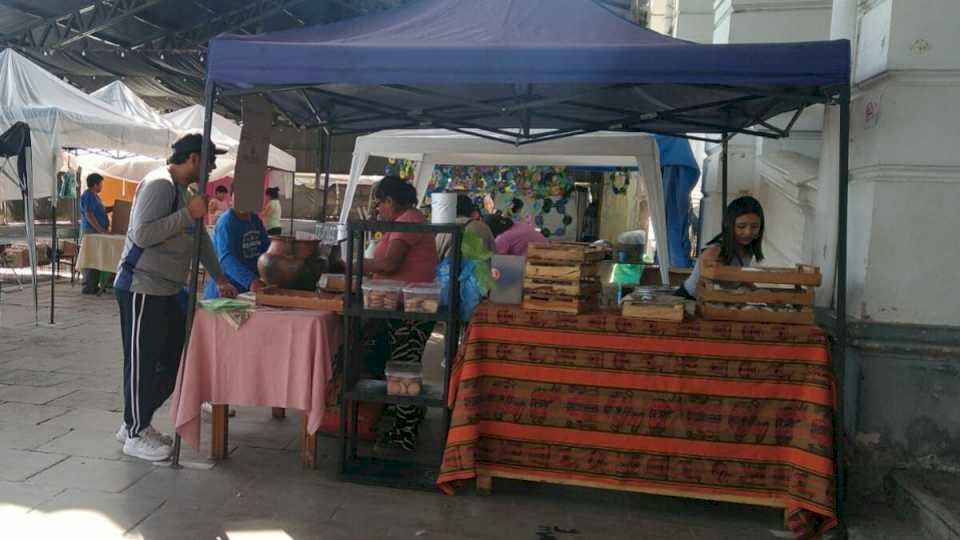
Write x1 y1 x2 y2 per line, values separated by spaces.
887 470 960 540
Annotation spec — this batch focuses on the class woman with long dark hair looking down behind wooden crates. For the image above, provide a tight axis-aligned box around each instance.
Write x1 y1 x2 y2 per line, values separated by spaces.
676 196 764 299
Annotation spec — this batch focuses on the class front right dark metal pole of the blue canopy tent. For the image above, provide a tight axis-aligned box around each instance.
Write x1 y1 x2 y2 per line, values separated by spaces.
833 86 850 523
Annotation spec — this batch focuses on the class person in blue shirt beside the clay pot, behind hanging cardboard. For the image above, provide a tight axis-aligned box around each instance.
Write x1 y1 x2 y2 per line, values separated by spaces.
205 208 270 299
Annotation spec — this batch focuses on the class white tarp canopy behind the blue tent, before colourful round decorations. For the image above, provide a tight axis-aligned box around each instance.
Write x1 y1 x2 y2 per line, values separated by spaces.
340 129 670 284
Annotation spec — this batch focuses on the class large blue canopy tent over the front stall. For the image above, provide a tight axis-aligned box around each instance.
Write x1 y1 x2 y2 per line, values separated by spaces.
182 0 850 520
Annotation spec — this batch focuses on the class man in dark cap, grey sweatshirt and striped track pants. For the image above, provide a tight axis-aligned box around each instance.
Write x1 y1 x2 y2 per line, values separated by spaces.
113 134 237 461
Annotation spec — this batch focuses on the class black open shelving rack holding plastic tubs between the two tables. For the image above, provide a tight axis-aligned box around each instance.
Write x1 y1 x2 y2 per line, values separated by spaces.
340 221 463 489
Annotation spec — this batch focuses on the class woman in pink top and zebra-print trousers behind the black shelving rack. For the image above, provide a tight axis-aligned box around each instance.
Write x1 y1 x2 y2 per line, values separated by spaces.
363 176 437 456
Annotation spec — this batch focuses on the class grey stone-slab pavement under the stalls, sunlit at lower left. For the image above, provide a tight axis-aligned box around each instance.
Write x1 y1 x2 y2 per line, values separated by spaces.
0 284 816 540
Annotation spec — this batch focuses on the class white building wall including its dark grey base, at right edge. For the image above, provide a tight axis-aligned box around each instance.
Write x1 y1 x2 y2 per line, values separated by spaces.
814 0 960 488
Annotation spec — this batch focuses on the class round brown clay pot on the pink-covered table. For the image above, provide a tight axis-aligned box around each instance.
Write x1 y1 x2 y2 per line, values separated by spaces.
257 236 327 291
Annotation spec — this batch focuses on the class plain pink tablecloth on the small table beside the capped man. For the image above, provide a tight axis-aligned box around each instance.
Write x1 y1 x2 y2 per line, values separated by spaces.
170 308 341 448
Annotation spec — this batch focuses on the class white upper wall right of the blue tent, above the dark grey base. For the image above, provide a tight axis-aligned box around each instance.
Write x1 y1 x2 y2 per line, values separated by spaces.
817 0 960 326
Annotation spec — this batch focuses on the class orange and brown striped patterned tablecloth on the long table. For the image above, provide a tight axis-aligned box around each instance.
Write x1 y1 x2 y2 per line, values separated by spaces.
438 304 836 537
